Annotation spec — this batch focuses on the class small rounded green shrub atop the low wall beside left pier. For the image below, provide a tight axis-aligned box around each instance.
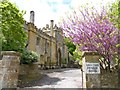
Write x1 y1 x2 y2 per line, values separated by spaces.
21 50 38 64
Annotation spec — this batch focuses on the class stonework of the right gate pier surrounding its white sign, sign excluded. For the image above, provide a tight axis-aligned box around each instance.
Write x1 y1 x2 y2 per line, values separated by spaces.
82 51 100 88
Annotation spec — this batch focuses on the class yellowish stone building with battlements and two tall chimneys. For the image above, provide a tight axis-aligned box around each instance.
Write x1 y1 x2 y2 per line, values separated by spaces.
25 11 68 67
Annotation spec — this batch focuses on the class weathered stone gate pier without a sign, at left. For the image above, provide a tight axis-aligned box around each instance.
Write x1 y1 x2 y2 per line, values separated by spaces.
0 51 20 89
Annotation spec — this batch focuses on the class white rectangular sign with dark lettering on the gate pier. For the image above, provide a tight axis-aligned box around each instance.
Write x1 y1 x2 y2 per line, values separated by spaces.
86 63 100 74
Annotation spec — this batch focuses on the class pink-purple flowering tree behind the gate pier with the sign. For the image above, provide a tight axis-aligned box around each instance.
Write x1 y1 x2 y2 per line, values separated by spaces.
60 8 119 67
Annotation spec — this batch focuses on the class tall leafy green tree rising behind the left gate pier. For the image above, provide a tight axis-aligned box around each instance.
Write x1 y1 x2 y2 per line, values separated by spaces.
0 0 27 51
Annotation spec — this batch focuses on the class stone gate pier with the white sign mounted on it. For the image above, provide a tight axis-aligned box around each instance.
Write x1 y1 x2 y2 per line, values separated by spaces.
82 51 101 88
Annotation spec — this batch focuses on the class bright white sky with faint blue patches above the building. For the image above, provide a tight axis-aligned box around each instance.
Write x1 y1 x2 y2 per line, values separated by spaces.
10 0 115 28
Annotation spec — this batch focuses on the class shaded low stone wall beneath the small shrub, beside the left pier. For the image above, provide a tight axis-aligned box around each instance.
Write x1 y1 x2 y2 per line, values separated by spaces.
18 64 44 87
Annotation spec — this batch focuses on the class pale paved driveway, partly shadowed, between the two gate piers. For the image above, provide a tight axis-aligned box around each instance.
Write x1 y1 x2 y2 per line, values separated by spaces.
18 68 82 90
